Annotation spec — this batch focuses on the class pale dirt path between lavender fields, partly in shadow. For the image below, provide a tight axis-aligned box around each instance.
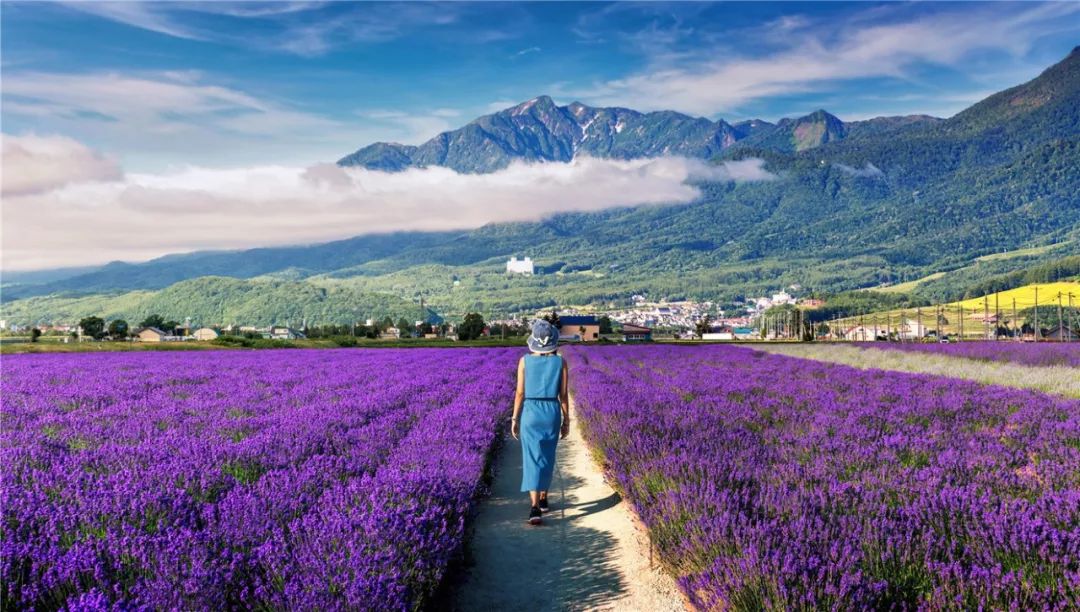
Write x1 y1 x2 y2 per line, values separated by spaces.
446 403 685 612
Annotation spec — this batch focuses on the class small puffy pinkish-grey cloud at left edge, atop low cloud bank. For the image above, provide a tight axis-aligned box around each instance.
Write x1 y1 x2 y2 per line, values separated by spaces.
0 134 123 196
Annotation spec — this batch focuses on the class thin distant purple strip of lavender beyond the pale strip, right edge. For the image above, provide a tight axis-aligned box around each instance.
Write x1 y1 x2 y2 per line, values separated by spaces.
860 341 1080 368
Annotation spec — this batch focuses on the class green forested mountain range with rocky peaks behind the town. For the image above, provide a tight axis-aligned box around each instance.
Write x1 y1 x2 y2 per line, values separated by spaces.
3 51 1080 325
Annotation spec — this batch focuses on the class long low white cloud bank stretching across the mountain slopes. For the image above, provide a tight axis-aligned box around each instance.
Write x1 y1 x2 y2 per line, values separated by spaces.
3 137 774 270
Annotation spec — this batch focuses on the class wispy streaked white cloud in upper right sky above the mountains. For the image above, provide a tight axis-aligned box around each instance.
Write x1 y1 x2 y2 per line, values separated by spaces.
579 2 1080 115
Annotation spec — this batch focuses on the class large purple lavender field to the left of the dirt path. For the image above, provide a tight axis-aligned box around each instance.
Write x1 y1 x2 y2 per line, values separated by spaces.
0 349 519 610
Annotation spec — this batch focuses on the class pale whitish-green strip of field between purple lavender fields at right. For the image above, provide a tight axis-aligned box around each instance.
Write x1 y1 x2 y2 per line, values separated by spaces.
755 342 1080 398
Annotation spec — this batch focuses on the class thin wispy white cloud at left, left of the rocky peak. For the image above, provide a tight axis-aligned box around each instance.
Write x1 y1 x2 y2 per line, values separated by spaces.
3 71 395 169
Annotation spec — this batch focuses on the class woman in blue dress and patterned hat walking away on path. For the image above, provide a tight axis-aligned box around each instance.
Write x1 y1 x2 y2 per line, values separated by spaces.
510 321 570 525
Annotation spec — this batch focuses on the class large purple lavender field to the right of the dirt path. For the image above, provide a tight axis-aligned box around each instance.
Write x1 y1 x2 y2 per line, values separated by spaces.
571 346 1080 610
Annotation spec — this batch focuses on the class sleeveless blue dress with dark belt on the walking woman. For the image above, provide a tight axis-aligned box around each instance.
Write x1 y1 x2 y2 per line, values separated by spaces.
519 355 563 491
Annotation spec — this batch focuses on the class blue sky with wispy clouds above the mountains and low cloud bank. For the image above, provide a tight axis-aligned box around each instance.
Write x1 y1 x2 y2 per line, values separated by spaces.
2 2 1080 171
